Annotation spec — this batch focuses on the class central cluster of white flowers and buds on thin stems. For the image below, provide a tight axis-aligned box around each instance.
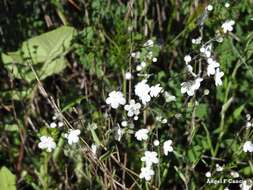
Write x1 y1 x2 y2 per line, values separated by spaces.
106 37 176 181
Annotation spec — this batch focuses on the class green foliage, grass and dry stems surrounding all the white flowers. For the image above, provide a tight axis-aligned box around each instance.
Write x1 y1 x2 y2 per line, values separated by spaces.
0 0 253 190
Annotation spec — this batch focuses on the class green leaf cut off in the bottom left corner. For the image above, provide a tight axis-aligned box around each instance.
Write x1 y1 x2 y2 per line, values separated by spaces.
0 167 16 190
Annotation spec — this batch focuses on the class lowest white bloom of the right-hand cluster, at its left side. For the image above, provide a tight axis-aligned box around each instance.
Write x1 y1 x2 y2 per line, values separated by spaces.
181 78 203 96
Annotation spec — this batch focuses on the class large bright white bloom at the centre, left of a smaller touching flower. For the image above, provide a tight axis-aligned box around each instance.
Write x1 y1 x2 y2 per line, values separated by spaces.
134 80 151 105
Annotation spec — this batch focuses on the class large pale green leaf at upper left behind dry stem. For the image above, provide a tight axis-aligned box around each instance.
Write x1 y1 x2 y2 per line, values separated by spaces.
2 26 76 82
